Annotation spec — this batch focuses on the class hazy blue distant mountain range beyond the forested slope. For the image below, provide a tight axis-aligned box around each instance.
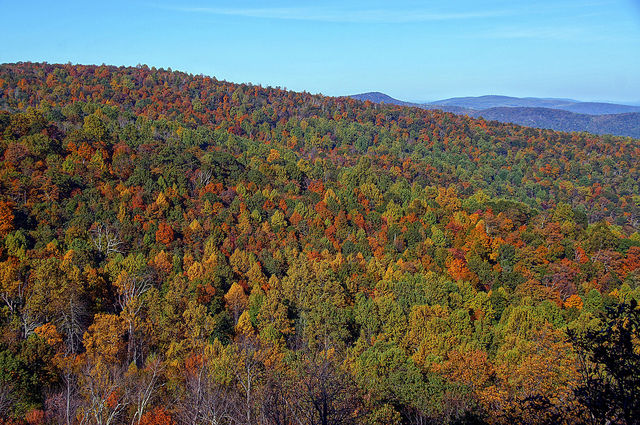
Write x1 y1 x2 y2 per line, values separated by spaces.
351 92 640 139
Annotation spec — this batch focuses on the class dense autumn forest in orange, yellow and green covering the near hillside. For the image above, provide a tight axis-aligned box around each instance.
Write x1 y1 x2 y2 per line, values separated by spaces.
0 63 640 425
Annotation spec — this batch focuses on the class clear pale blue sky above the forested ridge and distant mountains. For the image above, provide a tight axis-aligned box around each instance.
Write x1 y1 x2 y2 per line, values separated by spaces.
0 0 640 102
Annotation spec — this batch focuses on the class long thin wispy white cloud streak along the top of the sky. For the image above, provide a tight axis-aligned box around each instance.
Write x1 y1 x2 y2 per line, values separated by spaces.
163 6 509 23
